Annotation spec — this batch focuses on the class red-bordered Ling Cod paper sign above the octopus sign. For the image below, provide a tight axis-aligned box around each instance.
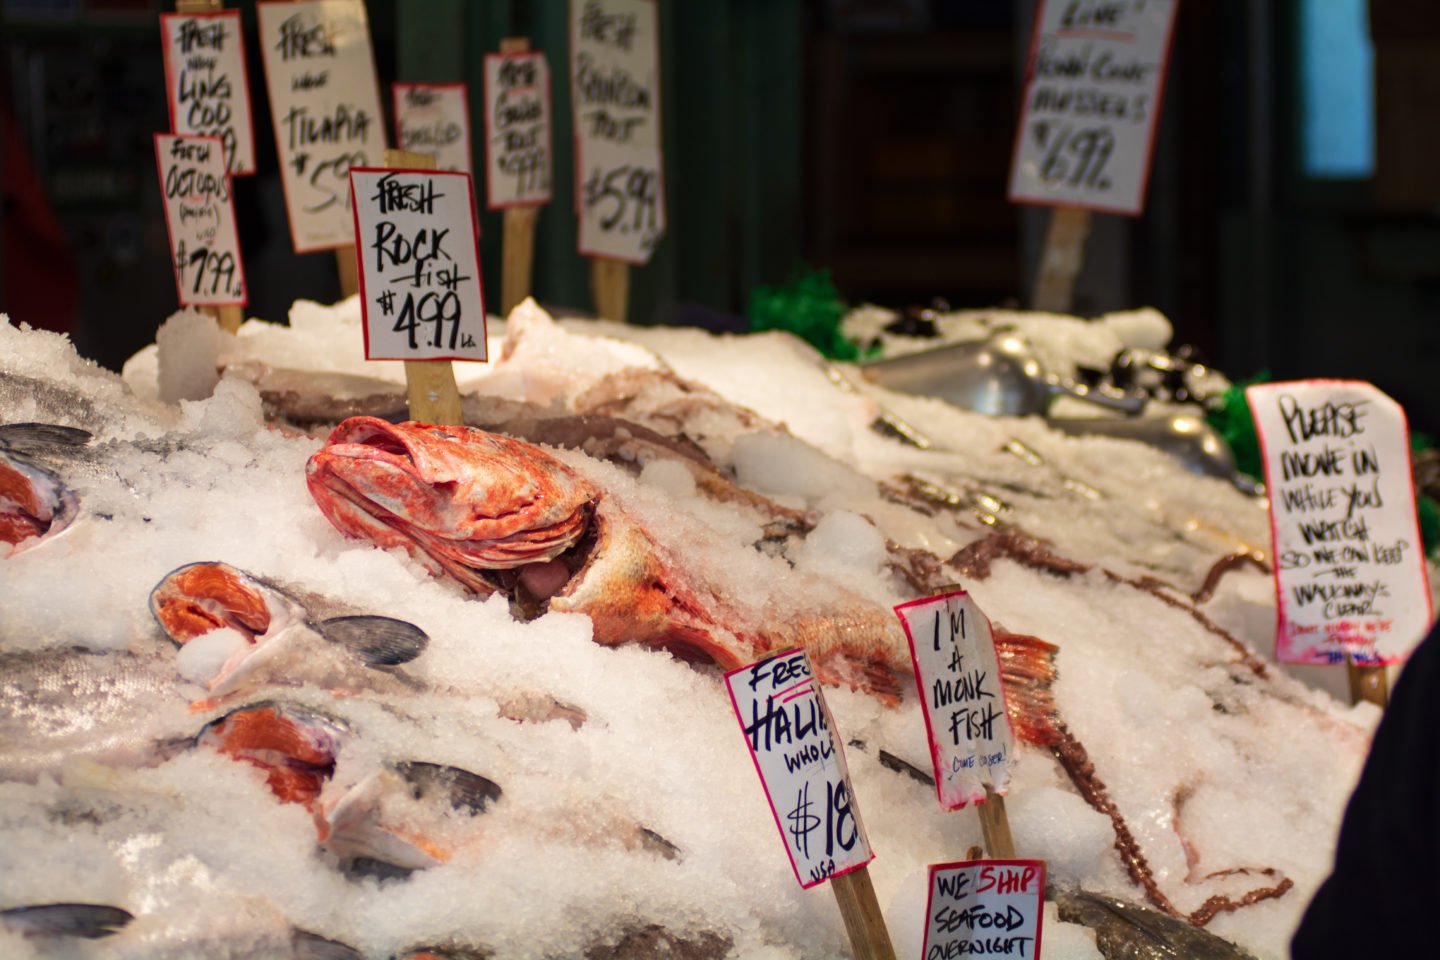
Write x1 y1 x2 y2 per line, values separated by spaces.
160 10 255 174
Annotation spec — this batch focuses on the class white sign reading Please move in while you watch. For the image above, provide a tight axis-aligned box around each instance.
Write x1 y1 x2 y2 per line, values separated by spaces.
1246 380 1430 666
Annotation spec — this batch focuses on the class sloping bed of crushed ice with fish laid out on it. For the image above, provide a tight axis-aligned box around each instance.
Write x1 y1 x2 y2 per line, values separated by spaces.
0 302 1378 960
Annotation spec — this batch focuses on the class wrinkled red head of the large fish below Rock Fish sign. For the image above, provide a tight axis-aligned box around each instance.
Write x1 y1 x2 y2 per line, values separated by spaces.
305 417 599 594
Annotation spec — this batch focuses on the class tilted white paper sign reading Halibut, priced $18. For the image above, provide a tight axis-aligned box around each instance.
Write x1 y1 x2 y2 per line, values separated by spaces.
726 649 874 888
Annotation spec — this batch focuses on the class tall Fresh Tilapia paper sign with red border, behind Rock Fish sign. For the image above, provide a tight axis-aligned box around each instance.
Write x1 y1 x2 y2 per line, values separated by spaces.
256 0 384 253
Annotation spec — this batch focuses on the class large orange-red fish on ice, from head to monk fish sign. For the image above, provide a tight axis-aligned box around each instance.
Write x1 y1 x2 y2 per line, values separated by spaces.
305 417 910 702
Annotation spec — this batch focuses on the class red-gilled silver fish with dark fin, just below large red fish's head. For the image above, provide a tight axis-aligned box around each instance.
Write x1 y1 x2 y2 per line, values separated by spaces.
150 561 429 708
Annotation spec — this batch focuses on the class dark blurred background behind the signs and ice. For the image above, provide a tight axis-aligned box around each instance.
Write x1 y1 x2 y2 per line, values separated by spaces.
0 0 1440 433
